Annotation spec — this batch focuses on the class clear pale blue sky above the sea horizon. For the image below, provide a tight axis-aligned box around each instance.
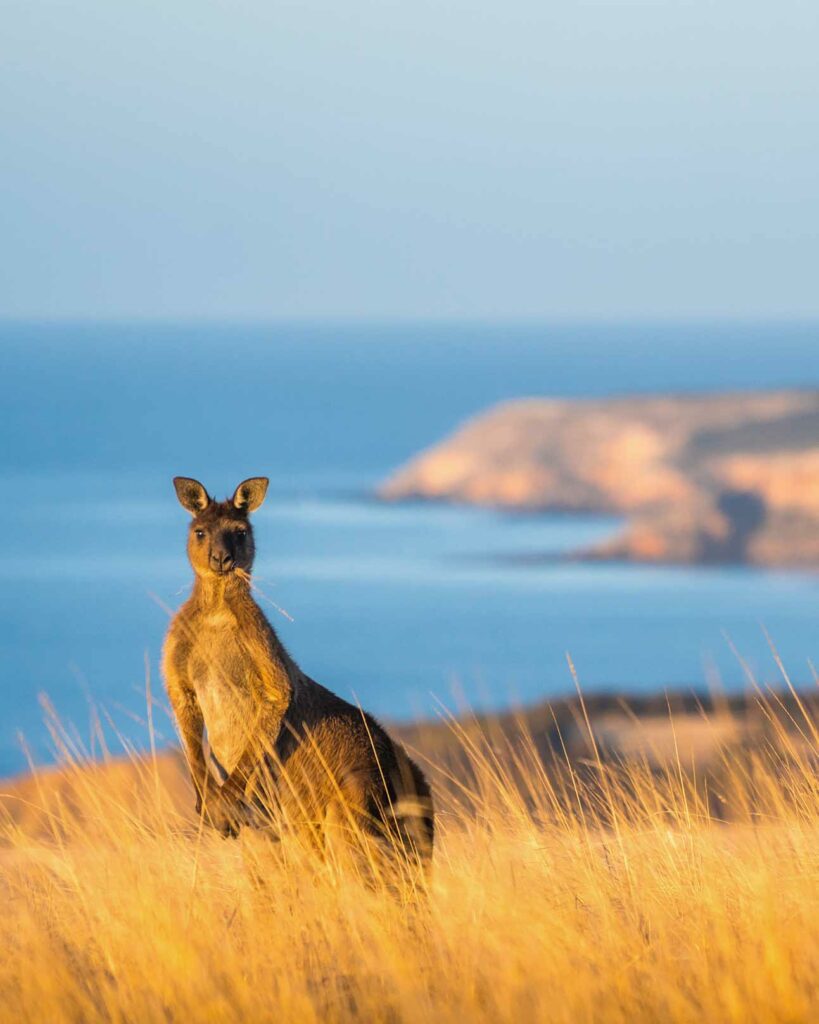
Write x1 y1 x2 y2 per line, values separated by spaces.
0 0 819 319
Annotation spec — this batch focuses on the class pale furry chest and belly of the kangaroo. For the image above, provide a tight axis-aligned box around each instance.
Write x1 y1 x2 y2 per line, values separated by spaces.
190 613 260 772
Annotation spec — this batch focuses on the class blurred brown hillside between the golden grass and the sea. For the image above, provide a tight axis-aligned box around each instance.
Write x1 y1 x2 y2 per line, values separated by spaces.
6 689 819 834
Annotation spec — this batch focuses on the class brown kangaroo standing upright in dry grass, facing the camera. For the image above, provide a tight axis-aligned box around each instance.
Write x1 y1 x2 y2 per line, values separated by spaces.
163 476 434 863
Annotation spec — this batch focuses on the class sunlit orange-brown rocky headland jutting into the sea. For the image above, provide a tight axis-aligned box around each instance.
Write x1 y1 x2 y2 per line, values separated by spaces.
379 390 819 566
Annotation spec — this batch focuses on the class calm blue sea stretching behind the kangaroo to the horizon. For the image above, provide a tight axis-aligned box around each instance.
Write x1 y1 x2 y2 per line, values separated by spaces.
0 323 819 775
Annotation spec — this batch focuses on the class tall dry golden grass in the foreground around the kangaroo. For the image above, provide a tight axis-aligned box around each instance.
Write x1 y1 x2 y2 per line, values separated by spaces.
0 696 819 1024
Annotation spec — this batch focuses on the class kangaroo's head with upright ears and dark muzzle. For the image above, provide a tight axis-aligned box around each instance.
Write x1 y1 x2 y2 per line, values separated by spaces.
173 476 268 578
